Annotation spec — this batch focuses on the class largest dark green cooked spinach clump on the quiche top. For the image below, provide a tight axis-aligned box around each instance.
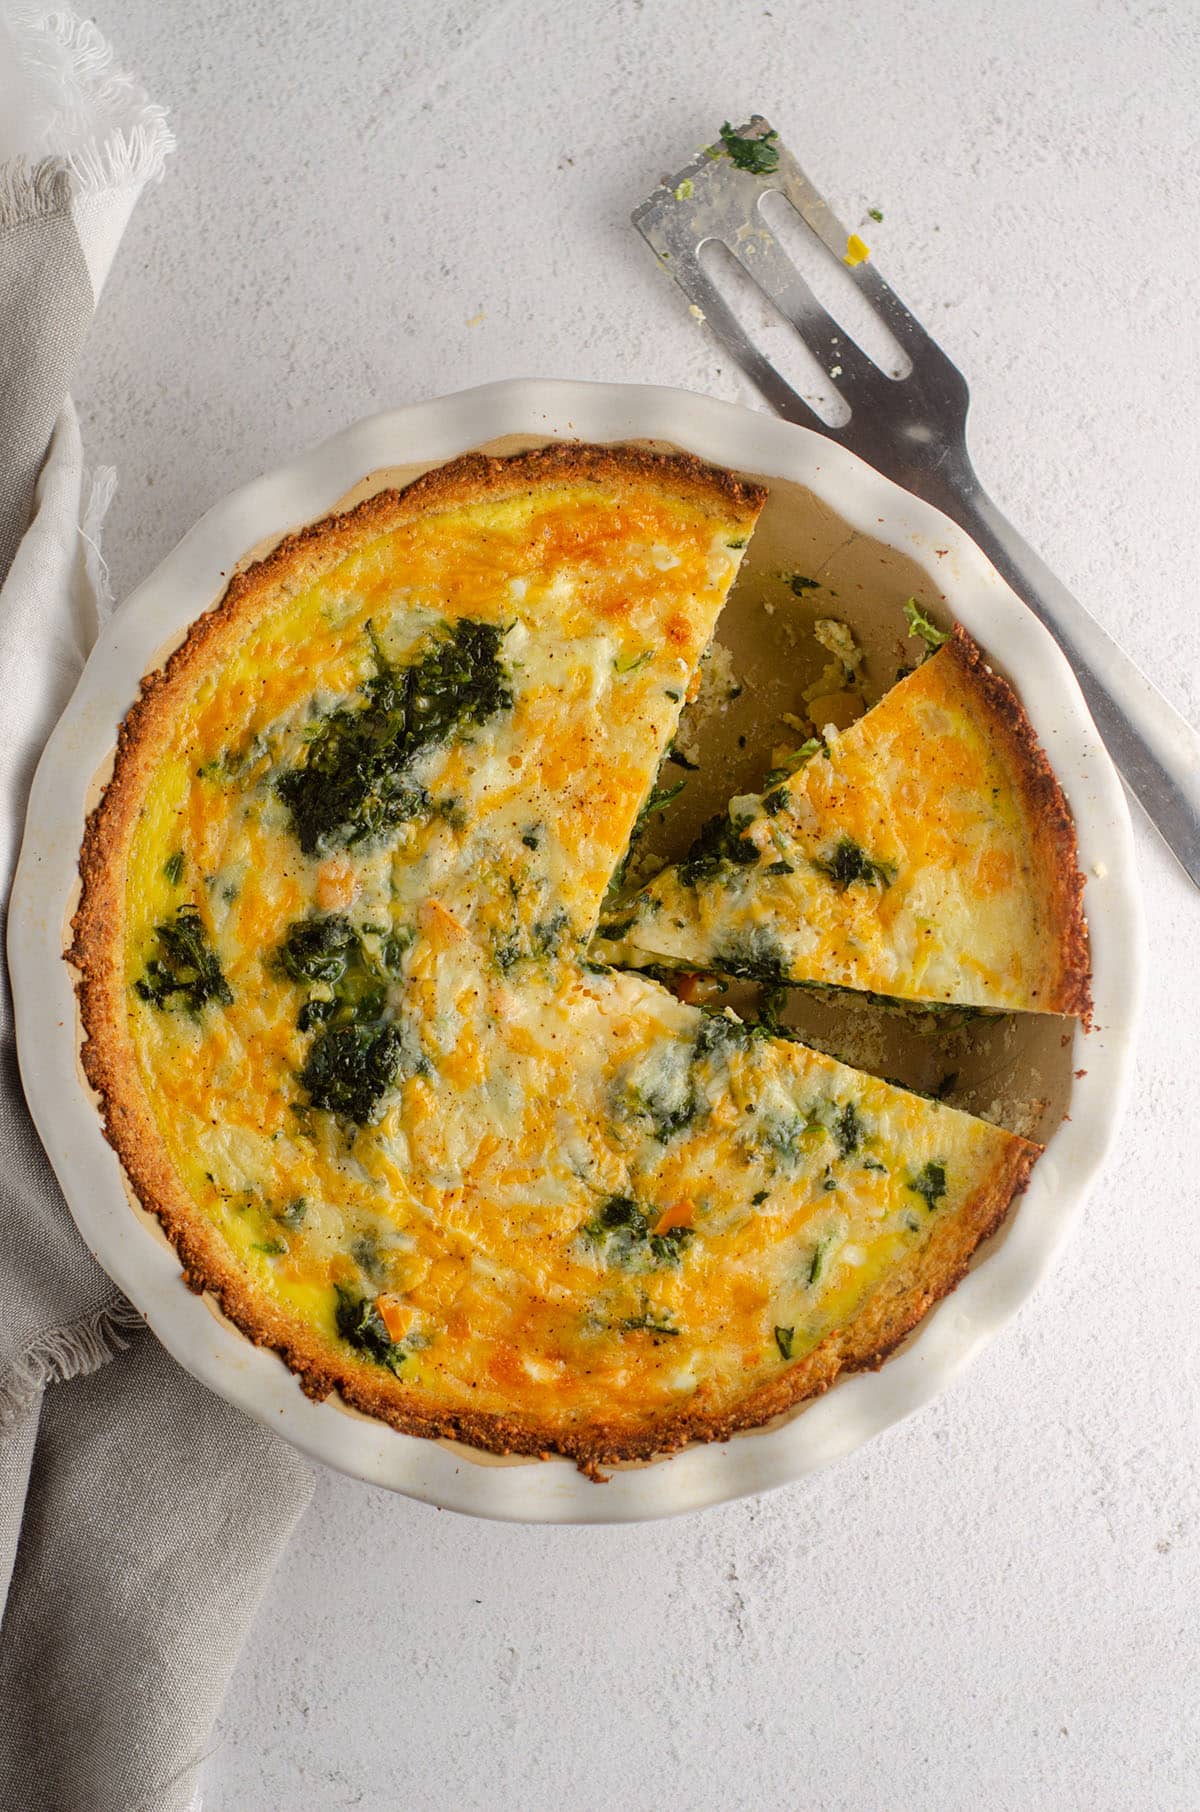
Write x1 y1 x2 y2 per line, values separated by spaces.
276 618 513 855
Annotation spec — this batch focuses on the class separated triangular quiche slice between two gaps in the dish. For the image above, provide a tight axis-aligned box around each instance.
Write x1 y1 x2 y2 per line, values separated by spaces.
602 627 1091 1020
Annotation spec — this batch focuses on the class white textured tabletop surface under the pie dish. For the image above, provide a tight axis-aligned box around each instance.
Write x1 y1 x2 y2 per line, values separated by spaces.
80 0 1200 1812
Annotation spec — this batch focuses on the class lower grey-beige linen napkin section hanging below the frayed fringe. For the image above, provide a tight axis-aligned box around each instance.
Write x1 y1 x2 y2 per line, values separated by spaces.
0 1332 310 1812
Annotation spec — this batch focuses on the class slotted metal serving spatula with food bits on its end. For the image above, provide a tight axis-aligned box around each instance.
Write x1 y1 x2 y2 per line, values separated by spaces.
633 114 1200 886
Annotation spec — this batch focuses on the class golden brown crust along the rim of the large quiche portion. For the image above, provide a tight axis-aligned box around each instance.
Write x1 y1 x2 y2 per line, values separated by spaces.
67 444 1044 1477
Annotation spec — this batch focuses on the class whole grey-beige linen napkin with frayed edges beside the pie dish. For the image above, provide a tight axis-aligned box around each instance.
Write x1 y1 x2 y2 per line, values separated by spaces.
0 10 312 1812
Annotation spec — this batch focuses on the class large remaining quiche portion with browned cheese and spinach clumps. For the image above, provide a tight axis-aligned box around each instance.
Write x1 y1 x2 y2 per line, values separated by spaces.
69 446 1069 1477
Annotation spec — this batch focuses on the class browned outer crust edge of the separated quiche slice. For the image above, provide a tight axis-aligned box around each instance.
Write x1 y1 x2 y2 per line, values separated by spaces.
944 623 1091 1026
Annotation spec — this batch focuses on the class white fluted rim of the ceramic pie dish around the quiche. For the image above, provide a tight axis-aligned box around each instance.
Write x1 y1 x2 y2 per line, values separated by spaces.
9 382 1142 1522
